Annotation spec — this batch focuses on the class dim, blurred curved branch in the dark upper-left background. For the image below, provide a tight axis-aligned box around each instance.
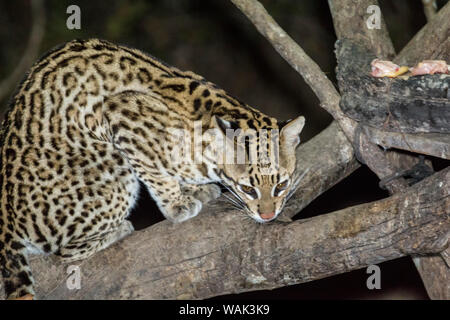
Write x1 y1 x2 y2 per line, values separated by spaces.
0 0 45 101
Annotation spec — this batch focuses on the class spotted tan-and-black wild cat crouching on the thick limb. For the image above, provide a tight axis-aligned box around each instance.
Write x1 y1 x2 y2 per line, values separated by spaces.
0 39 304 298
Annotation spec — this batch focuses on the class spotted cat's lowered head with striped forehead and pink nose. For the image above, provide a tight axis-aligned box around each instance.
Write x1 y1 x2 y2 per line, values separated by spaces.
213 116 305 223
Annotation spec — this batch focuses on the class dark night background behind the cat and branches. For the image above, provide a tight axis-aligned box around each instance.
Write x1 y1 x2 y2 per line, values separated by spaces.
0 0 446 299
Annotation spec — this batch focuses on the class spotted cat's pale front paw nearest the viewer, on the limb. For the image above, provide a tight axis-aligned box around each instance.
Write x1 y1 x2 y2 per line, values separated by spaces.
161 195 202 223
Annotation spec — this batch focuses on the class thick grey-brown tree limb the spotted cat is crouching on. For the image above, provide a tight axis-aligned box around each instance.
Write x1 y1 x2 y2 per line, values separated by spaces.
0 169 450 299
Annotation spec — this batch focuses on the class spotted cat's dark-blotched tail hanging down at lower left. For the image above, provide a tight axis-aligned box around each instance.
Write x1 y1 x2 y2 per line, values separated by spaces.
0 230 34 300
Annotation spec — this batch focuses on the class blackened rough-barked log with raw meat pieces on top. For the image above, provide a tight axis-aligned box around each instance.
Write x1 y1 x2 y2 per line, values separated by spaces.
336 39 450 134
